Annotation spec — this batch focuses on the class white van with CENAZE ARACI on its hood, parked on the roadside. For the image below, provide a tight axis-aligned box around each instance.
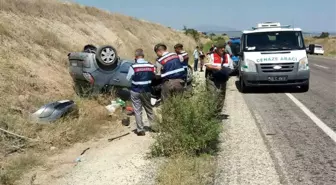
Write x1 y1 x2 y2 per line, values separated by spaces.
239 22 310 93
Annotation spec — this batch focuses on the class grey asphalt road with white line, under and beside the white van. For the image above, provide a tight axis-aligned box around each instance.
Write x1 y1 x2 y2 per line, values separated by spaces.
243 56 336 185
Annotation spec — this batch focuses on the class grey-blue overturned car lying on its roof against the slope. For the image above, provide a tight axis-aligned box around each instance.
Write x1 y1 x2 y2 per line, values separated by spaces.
68 45 192 100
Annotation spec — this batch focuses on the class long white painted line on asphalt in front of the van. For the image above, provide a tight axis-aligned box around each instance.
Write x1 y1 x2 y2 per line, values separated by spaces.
286 93 336 142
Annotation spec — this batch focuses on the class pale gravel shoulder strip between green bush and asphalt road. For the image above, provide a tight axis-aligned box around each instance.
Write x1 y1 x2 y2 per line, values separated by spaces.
215 77 281 185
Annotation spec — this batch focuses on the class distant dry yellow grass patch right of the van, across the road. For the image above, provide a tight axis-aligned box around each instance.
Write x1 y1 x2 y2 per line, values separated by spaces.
305 37 336 56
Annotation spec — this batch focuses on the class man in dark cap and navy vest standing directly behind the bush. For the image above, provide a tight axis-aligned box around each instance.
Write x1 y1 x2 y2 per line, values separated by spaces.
154 44 186 101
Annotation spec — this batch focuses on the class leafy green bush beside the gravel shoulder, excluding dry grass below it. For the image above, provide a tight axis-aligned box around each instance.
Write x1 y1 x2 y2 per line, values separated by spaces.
152 85 221 156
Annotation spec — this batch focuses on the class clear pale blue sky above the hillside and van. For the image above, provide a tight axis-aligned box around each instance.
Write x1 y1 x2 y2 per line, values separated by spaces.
72 0 336 32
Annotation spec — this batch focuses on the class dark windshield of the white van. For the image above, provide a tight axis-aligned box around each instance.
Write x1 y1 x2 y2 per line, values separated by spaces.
244 31 305 51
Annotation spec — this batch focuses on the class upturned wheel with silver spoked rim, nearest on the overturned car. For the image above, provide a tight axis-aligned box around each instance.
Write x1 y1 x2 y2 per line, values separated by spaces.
96 46 118 70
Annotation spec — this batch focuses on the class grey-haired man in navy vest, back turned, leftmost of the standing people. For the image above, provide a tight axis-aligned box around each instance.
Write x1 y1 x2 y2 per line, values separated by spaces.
126 49 155 136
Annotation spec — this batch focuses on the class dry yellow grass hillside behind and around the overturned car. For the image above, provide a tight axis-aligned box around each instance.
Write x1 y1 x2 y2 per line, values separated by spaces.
0 0 207 183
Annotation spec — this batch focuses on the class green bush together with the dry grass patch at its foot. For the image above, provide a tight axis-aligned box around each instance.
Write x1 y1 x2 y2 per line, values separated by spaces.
152 79 221 185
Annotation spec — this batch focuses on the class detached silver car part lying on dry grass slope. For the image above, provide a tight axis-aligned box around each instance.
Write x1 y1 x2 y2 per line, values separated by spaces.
31 100 78 123
